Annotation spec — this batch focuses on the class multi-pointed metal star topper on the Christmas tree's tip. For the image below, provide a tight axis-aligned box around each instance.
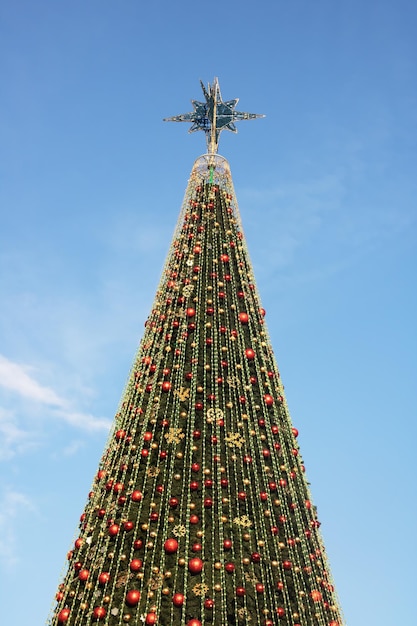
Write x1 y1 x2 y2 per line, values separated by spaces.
164 78 265 154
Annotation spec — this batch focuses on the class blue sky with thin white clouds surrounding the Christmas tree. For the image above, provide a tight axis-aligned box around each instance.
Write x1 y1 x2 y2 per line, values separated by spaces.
0 0 417 626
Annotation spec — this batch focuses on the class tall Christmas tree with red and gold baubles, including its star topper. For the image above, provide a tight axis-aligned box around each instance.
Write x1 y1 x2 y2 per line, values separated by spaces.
48 79 343 626
